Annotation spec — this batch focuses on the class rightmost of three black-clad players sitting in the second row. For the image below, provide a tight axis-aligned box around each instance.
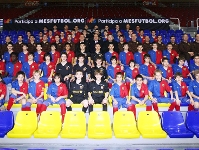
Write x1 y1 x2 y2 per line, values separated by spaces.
91 57 108 81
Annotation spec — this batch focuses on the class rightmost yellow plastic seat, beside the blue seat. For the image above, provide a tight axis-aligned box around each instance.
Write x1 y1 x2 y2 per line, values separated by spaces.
138 111 167 138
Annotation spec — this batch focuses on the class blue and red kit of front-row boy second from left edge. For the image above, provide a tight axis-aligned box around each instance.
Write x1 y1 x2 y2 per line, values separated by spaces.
7 80 28 111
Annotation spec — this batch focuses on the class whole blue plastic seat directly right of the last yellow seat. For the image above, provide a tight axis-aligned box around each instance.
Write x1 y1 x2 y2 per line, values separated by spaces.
162 111 194 138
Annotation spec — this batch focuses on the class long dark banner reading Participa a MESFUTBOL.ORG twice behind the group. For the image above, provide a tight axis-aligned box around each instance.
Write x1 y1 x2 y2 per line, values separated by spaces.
4 18 170 30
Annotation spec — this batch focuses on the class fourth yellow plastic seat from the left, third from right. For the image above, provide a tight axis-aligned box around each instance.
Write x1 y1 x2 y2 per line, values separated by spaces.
88 111 112 139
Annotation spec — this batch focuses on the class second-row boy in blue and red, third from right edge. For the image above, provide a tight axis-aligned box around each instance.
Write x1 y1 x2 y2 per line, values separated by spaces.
158 58 173 83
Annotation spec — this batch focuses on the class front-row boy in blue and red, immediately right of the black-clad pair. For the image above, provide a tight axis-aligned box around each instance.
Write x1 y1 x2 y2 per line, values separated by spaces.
110 72 132 114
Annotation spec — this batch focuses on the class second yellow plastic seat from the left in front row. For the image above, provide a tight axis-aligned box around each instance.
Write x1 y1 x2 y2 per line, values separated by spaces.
34 111 62 138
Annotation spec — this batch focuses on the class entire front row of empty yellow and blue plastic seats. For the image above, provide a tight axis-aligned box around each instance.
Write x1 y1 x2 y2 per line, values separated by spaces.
0 111 199 139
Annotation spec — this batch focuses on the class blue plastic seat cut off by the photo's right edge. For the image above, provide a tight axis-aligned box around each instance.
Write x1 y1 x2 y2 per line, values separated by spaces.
186 111 199 138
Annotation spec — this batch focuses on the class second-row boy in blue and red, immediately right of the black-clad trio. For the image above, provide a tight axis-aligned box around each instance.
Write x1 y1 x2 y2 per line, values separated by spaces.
107 56 123 88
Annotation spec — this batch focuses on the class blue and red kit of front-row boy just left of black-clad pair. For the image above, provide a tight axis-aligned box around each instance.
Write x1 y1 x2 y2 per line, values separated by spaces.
40 83 68 122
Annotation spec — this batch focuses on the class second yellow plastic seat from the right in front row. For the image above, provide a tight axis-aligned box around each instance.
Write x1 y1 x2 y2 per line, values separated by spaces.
113 111 140 138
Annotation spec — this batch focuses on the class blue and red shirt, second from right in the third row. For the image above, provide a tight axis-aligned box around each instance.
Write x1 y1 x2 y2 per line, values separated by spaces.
148 50 162 65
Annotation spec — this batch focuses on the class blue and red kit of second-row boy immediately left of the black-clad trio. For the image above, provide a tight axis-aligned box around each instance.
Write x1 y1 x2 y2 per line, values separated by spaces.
39 62 55 83
